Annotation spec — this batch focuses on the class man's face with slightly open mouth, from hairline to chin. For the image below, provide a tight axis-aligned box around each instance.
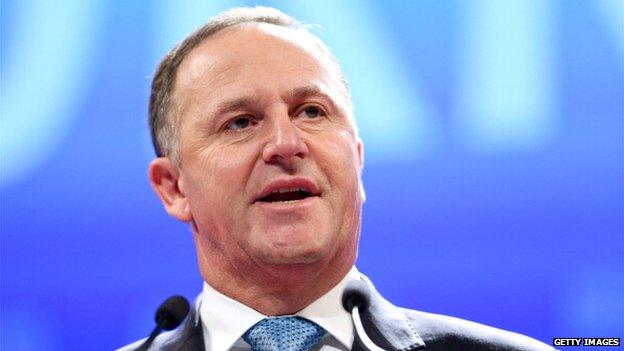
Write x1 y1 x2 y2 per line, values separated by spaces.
166 24 363 284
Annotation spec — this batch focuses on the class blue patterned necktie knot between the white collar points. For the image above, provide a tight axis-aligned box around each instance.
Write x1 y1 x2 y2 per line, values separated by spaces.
243 317 325 351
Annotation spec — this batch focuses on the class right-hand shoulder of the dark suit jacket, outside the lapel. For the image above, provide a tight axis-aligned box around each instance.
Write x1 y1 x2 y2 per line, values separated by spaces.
401 308 554 351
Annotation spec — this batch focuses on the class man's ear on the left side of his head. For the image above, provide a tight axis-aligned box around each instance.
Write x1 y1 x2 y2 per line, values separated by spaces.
148 157 192 222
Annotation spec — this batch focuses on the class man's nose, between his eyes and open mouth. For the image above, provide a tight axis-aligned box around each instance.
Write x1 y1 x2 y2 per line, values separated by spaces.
262 110 309 166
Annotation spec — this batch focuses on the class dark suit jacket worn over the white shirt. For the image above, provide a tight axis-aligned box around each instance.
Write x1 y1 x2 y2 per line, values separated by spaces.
118 278 554 351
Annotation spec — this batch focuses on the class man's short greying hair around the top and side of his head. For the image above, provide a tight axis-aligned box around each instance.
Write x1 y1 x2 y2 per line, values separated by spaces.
149 6 355 162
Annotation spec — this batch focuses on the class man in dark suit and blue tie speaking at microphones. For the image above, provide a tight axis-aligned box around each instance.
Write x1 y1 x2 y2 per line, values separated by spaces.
119 7 551 351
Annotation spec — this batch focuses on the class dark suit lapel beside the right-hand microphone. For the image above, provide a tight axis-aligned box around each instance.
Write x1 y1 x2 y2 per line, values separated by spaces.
352 275 425 351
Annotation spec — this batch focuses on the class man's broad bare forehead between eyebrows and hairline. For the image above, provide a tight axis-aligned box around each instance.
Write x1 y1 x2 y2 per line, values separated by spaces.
175 23 341 109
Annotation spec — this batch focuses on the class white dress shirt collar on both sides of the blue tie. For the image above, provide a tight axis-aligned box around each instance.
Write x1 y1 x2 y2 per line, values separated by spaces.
199 266 360 351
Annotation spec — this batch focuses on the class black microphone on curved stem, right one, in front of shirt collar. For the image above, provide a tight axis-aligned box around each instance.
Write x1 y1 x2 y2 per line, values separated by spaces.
342 280 385 351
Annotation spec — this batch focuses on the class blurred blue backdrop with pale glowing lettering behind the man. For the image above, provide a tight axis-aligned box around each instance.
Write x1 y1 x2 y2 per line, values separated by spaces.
0 0 624 350
